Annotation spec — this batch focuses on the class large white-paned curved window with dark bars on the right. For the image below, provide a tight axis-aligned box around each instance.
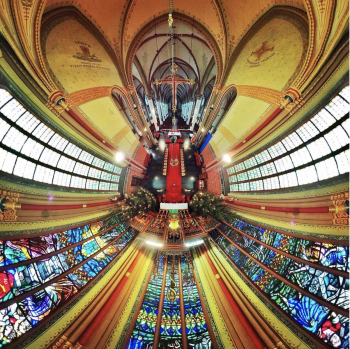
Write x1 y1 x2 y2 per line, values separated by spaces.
226 87 350 192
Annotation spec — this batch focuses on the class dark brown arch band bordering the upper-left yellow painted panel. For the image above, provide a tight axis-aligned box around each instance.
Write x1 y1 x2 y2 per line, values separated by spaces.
38 6 126 92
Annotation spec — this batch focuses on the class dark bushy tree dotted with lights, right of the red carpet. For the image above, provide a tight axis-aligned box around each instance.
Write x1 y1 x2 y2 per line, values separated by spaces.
190 192 232 221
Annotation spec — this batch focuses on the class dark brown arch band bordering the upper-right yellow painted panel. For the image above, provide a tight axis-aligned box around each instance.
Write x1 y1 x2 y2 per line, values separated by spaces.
222 6 309 88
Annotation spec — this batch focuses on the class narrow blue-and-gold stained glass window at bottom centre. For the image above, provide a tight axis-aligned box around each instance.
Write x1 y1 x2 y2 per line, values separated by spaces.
127 252 212 349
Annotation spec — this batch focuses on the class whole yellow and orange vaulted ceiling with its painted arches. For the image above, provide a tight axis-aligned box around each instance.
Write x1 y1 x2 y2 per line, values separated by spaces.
0 0 349 162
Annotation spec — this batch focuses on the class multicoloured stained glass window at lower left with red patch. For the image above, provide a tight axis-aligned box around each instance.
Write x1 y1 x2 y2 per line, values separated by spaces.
0 217 138 346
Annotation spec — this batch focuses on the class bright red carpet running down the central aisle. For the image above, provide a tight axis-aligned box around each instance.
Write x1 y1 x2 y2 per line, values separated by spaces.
166 143 182 202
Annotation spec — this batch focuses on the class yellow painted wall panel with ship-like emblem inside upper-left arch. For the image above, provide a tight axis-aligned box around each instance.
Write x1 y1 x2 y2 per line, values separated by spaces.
43 19 121 93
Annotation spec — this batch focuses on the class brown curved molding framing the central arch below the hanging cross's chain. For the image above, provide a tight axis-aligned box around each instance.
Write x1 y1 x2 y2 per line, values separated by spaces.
125 12 223 88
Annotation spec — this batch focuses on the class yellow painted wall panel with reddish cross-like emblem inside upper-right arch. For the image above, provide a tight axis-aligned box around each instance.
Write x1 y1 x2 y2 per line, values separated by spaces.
227 16 307 90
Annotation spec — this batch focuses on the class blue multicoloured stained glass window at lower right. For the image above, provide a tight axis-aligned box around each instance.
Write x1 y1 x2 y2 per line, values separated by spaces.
209 218 349 348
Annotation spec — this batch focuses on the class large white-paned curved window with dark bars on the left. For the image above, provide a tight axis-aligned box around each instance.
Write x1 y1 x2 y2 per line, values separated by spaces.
0 89 122 191
